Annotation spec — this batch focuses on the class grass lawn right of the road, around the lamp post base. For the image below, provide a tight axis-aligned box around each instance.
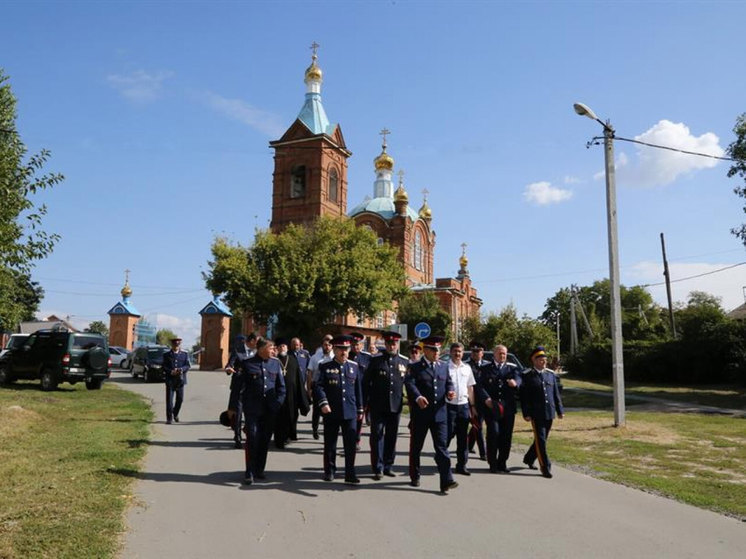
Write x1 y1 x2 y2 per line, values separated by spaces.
514 379 746 520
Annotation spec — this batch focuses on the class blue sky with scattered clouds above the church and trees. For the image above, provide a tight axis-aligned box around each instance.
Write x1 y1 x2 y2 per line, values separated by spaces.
0 1 746 342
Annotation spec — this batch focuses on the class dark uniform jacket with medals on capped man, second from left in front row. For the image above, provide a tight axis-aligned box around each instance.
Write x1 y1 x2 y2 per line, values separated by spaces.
313 359 363 419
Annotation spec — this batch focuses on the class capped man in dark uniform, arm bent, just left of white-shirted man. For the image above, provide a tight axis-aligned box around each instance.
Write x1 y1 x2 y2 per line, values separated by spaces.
404 336 458 493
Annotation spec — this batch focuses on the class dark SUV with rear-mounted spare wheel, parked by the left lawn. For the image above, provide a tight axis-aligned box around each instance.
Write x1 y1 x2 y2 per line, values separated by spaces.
0 328 111 390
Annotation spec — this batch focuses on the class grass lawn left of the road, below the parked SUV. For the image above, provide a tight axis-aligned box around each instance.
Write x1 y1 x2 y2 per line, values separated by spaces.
0 382 152 559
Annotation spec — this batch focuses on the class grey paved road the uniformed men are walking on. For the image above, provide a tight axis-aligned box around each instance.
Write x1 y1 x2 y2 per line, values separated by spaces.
112 371 746 559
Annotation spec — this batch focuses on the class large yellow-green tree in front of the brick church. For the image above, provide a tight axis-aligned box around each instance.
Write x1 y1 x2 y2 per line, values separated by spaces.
203 218 406 342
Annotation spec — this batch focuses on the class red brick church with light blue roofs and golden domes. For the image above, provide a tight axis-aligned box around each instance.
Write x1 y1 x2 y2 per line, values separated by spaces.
264 44 482 338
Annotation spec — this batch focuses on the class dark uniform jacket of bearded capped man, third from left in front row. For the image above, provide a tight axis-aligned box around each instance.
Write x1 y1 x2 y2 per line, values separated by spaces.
363 352 409 413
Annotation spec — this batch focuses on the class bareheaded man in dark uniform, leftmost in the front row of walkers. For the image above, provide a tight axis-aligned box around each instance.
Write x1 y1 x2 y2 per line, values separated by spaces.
241 338 285 485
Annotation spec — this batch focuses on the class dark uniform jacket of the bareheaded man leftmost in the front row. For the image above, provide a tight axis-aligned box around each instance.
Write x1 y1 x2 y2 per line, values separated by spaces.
239 355 285 416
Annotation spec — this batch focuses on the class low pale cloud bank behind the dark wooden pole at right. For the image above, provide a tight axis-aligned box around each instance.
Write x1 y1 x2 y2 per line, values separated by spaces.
622 261 746 311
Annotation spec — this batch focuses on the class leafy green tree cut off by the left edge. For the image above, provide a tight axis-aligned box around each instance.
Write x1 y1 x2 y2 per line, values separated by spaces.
0 69 63 329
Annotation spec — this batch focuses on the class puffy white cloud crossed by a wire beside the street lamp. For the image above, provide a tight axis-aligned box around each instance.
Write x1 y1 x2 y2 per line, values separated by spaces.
594 120 725 186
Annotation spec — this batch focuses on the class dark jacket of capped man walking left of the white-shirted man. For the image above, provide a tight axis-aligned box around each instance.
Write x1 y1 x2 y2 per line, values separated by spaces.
404 357 454 421
